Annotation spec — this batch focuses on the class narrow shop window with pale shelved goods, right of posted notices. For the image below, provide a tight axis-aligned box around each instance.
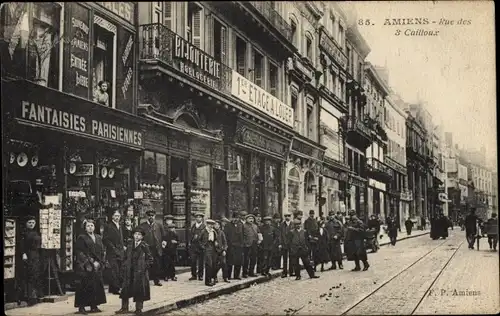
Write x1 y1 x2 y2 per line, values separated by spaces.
191 162 212 223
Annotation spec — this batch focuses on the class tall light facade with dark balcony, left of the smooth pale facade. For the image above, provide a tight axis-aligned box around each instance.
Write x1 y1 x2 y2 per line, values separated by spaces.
363 63 392 218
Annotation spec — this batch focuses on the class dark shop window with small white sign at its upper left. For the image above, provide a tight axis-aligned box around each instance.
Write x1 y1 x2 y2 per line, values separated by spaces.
228 151 249 216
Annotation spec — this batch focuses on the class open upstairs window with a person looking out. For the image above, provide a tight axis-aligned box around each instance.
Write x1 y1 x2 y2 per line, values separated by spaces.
92 15 116 108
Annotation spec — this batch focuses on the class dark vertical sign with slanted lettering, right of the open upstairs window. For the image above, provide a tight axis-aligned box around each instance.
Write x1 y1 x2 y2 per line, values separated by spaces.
116 27 135 112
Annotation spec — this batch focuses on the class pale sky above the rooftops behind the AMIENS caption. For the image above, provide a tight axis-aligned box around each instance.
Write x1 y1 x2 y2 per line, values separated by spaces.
353 1 497 163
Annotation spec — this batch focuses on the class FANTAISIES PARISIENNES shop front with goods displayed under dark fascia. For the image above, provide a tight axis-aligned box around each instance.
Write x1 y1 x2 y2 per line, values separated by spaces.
2 80 146 298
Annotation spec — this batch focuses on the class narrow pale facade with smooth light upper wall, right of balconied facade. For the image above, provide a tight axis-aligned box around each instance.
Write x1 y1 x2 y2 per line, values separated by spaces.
385 94 412 227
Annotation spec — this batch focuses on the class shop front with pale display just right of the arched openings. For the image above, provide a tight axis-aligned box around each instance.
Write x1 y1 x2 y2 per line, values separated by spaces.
319 158 349 216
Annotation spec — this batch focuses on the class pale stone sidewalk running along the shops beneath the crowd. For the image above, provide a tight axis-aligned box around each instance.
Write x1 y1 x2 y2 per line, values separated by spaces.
6 230 429 316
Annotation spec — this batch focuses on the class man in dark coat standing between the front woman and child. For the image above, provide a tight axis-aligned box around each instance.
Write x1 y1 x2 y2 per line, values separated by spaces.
102 209 125 294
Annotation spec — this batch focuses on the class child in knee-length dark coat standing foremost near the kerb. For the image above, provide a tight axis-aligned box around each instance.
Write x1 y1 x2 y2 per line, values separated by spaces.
116 226 154 315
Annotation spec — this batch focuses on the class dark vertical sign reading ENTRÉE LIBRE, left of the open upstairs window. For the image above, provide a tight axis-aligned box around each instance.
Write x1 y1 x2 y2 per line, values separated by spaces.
63 3 91 99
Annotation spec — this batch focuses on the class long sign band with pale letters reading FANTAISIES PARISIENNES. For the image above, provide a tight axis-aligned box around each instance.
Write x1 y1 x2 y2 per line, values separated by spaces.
16 96 143 147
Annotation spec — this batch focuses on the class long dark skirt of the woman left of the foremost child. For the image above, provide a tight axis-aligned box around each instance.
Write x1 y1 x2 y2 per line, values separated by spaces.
75 271 106 307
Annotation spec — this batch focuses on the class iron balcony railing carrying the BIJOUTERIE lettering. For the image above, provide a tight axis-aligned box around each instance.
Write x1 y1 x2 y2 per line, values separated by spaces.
139 23 232 94
